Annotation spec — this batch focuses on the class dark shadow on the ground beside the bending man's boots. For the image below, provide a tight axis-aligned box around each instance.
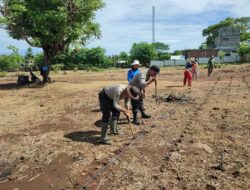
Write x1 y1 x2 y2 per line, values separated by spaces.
64 131 100 145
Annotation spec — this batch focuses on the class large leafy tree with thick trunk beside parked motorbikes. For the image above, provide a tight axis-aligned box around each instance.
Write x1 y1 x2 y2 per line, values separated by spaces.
0 0 104 82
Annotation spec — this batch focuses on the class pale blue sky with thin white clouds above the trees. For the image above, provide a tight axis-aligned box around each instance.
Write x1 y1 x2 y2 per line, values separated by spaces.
0 0 250 55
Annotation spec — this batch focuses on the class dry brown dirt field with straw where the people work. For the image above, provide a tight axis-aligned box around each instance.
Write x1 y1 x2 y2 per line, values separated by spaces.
0 64 250 190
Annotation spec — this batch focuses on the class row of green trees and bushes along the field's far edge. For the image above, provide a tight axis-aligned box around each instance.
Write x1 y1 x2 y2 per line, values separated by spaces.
0 42 170 71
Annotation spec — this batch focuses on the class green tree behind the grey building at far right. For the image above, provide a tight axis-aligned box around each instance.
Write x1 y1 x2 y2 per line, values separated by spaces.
202 17 250 48
